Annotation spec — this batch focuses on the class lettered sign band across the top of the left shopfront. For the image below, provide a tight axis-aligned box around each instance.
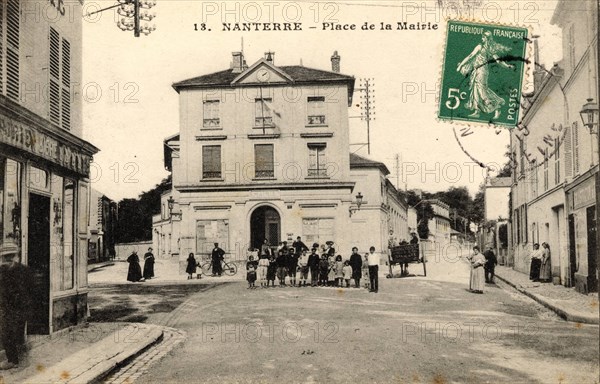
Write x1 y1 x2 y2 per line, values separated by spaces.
0 115 92 176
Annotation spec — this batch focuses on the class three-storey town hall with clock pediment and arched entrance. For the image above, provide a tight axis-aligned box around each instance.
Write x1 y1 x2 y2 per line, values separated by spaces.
153 52 407 269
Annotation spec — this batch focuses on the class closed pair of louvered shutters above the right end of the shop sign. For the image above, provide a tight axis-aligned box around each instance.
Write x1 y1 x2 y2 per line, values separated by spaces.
49 28 71 129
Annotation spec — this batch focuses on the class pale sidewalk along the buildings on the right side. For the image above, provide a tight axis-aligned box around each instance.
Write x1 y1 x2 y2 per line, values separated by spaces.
496 266 599 324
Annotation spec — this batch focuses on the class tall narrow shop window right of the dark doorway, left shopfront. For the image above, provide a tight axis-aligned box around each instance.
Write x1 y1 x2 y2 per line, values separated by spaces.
61 179 75 290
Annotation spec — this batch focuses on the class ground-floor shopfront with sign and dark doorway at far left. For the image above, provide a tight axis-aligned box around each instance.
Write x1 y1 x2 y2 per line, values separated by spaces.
0 97 98 334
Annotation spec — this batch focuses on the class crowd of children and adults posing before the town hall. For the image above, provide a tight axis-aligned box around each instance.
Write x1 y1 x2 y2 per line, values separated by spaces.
246 238 369 289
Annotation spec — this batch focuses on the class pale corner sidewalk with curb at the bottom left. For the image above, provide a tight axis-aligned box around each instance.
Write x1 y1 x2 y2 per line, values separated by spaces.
0 323 163 384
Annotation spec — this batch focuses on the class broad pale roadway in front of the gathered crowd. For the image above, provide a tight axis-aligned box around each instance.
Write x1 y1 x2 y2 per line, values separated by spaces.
90 257 598 383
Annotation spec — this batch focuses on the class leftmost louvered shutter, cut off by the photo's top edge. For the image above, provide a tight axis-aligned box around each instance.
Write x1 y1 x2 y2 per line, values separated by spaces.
6 0 20 100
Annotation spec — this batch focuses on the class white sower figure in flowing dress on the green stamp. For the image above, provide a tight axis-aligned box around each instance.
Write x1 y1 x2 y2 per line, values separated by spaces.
456 31 514 120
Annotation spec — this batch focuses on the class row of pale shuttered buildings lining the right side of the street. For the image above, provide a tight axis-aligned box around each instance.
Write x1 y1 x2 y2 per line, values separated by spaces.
509 0 598 292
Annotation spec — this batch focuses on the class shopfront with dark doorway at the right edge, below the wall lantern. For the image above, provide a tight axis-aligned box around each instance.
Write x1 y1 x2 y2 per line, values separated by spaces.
567 166 598 293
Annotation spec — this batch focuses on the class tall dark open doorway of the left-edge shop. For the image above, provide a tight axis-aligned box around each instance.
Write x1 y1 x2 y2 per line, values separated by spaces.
27 193 50 335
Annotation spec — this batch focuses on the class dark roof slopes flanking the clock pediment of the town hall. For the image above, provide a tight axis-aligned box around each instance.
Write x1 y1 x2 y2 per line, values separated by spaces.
173 65 354 92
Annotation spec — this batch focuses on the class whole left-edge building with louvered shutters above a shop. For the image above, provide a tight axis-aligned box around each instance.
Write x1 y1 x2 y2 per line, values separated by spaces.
0 0 98 334
